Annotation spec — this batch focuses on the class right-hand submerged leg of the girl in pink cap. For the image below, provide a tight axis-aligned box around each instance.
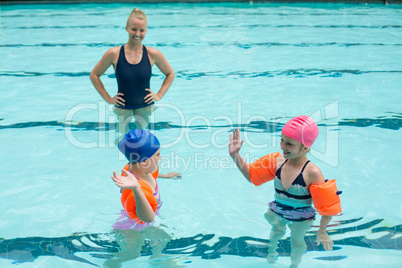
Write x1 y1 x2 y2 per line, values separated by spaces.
289 220 313 268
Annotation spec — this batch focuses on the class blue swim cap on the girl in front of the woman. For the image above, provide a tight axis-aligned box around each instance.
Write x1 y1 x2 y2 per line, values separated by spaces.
118 129 161 163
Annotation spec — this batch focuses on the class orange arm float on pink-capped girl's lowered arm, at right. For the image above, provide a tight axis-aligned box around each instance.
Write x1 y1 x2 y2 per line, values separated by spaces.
310 180 342 216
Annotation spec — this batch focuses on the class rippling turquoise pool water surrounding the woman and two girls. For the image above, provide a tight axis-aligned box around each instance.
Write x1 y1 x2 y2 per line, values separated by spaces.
0 3 402 267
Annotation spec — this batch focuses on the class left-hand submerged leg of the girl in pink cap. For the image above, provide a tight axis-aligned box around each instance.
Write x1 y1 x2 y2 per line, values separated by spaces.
264 210 286 263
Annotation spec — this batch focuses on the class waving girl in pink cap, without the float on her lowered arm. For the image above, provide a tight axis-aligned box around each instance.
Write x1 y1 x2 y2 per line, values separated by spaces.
229 115 333 267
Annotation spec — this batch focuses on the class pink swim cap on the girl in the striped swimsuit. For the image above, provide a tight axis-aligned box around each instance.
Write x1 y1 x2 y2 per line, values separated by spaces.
282 115 319 147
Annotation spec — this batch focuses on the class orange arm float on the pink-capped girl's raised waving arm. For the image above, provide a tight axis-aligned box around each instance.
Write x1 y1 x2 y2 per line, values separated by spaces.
250 152 280 186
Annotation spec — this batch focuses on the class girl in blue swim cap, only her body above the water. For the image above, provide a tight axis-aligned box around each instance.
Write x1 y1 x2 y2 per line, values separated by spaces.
112 129 180 227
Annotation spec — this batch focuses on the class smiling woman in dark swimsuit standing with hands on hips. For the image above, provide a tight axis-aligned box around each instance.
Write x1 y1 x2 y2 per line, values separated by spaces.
90 8 175 144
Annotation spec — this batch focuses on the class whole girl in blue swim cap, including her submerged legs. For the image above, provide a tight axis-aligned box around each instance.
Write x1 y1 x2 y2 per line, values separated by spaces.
107 129 180 267
